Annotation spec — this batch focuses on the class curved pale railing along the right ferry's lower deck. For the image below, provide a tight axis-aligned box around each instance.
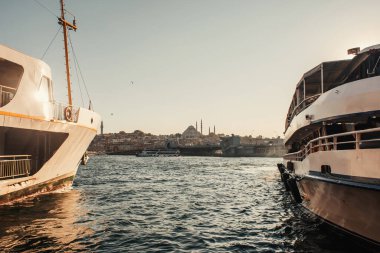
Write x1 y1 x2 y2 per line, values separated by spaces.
284 127 380 161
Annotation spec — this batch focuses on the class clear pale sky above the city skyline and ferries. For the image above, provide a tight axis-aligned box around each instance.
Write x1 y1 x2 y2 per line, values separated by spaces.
0 0 380 137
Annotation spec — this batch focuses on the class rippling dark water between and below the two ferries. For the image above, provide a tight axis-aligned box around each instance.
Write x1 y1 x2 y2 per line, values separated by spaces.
0 156 372 252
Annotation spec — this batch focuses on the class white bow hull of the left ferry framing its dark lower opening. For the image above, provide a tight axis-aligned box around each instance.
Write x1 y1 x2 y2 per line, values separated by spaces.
0 111 100 204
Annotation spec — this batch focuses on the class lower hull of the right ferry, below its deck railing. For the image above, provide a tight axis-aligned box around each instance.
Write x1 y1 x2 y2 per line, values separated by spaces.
285 149 380 245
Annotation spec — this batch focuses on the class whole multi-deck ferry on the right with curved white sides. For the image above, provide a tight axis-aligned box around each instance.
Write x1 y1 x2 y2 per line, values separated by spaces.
278 45 380 246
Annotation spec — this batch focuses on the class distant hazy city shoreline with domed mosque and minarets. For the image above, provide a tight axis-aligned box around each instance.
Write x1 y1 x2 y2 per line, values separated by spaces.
88 120 286 157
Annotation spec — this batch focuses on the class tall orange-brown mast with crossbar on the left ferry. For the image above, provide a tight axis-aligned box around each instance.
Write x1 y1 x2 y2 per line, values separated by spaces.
58 0 77 107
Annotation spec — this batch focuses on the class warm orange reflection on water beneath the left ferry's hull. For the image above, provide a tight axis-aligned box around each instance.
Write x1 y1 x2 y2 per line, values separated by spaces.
0 189 94 251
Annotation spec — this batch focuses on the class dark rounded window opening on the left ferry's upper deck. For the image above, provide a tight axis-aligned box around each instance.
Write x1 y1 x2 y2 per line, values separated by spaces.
0 58 24 106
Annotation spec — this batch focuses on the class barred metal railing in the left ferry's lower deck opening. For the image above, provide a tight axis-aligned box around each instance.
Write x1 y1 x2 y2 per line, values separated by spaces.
0 155 31 179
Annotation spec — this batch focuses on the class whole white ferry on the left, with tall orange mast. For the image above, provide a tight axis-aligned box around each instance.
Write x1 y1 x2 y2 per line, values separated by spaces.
0 0 100 204
